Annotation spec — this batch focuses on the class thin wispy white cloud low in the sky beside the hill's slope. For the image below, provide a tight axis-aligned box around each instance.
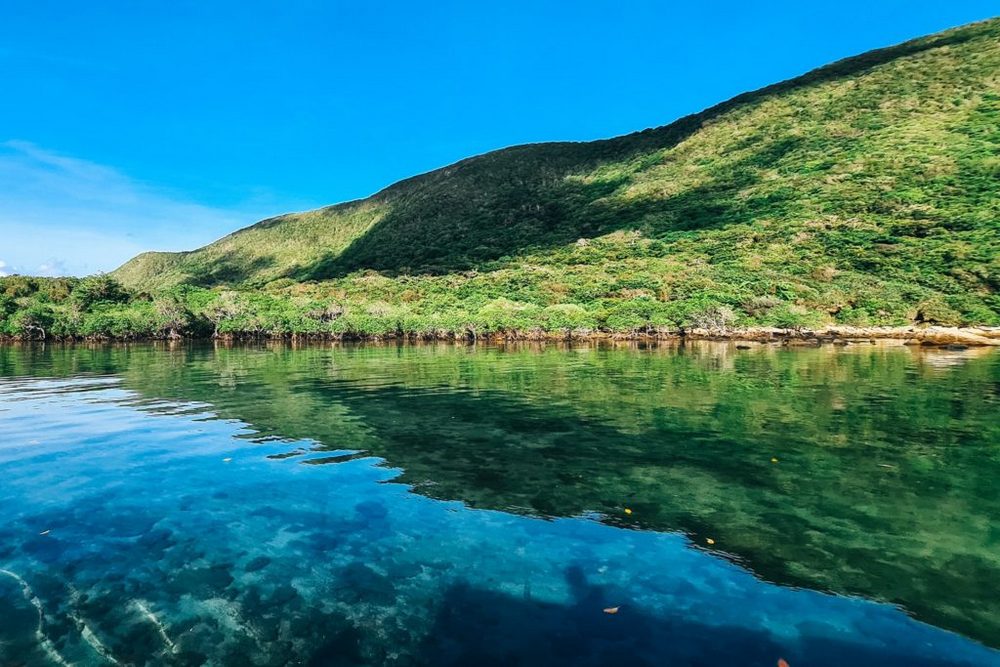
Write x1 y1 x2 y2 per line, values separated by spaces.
0 141 272 275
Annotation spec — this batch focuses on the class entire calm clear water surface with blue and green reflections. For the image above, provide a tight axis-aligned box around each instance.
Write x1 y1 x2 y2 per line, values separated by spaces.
0 343 1000 667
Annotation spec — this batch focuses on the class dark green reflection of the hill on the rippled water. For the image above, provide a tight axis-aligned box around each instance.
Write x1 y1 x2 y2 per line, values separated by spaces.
0 343 1000 645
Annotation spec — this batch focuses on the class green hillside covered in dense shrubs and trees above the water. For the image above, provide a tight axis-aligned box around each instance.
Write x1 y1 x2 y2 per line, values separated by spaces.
0 20 1000 336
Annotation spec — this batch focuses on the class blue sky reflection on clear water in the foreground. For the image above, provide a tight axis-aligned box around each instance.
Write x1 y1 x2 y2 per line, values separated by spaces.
0 380 1000 667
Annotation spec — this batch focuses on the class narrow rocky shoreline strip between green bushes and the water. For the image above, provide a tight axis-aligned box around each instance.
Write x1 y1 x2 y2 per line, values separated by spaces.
0 325 1000 347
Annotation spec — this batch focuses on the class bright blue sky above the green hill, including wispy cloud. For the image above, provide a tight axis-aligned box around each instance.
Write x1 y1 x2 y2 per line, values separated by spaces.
0 0 997 275
